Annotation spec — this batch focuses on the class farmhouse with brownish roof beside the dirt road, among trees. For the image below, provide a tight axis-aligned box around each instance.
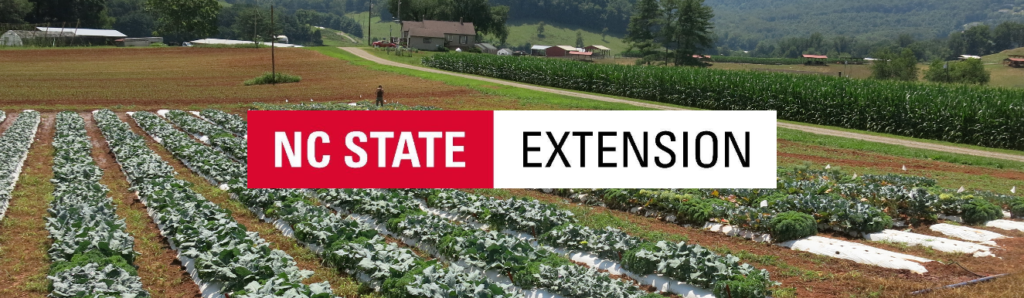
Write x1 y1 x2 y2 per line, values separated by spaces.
401 19 477 50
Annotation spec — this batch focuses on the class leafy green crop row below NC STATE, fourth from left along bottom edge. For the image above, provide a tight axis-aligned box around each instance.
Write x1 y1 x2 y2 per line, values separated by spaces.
317 188 660 298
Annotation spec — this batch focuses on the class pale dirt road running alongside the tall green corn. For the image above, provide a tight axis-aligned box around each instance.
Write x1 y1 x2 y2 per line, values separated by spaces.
341 47 1024 162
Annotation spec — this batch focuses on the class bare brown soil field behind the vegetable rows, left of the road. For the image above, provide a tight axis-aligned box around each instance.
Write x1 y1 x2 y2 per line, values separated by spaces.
0 47 544 111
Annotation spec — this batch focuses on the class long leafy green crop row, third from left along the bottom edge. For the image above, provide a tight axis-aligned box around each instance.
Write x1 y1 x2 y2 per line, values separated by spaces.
132 112 514 297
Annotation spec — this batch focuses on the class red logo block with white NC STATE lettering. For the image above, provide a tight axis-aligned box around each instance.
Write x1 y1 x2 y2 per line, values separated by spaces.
248 111 495 188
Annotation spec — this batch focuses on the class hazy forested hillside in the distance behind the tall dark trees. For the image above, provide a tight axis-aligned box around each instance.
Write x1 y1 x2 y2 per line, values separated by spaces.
490 0 1024 49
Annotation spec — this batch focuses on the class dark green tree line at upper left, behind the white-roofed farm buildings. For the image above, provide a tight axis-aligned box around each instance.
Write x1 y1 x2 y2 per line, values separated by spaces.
0 0 362 45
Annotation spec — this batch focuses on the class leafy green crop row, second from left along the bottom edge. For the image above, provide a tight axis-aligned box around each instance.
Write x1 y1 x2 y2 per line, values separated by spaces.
94 110 331 298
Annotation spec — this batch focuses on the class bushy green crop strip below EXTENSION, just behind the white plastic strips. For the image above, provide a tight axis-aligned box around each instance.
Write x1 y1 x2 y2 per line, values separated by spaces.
556 169 1024 242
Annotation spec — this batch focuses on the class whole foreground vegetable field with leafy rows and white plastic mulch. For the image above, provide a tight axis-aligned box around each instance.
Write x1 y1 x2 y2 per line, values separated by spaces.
0 101 1024 298
